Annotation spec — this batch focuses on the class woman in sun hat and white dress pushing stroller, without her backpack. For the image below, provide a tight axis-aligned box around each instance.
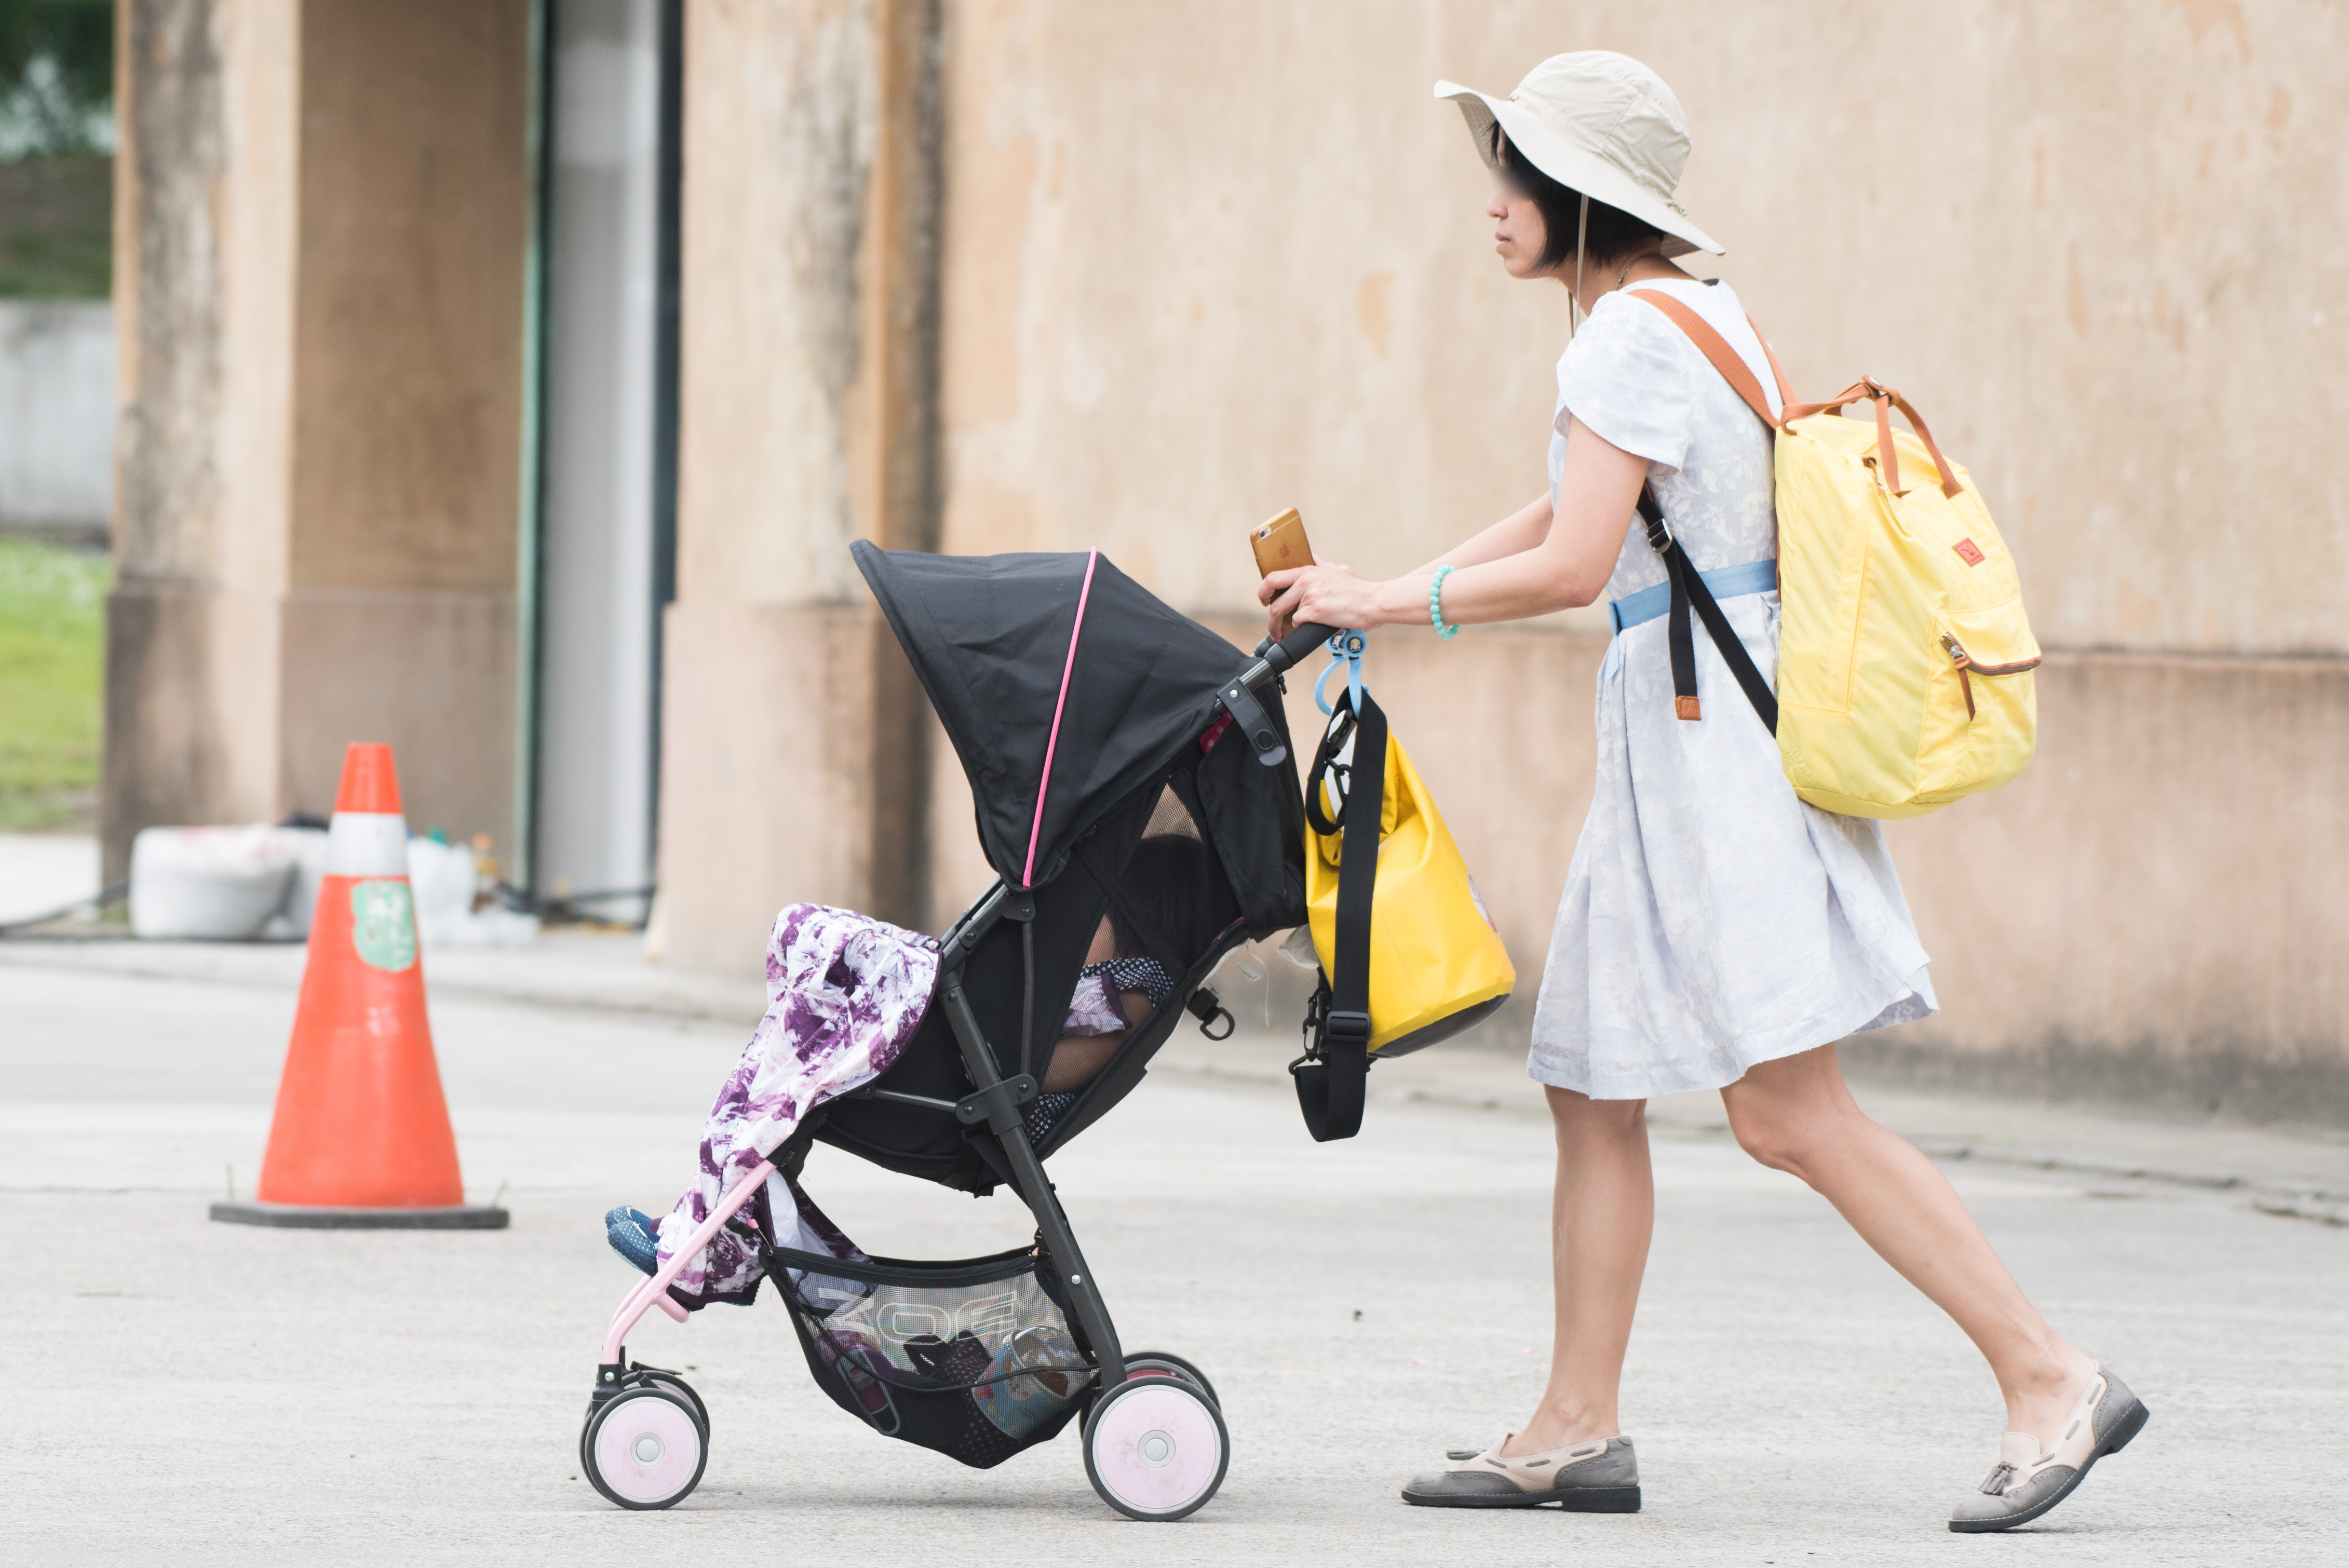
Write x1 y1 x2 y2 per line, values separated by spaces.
1264 51 2147 1533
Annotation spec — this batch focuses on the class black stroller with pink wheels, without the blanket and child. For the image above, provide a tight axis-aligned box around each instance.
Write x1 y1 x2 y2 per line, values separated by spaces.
580 545 1330 1519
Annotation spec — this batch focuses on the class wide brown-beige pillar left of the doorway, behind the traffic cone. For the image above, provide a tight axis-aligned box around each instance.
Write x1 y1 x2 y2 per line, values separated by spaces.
101 0 531 875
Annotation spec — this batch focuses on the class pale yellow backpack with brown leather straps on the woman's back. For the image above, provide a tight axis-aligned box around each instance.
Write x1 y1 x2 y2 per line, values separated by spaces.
1630 289 2039 817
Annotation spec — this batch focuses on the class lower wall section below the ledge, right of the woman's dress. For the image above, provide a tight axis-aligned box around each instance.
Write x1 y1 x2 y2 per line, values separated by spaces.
1879 653 2349 1125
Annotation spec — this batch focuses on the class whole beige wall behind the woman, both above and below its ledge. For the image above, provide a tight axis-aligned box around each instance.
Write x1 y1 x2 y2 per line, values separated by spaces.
902 0 2349 1117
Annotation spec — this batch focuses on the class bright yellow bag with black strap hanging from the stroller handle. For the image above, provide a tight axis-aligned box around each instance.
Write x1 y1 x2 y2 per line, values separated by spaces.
1294 693 1518 1141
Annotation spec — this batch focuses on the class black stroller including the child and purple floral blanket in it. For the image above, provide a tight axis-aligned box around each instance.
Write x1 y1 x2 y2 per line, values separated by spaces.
580 545 1330 1519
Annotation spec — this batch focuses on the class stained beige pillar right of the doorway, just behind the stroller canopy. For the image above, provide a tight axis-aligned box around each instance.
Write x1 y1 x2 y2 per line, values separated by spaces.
655 0 937 967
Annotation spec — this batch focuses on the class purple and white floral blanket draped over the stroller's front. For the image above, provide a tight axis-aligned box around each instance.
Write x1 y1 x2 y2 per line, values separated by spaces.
660 904 937 1305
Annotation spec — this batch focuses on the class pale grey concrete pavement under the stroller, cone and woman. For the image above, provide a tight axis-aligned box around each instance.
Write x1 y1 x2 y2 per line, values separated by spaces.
0 937 2349 1563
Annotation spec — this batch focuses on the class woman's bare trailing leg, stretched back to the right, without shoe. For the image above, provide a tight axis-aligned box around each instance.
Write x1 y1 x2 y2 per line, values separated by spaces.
1722 1045 2095 1441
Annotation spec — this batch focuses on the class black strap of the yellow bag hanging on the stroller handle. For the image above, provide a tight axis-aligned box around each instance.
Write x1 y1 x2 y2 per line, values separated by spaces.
1292 693 1386 1143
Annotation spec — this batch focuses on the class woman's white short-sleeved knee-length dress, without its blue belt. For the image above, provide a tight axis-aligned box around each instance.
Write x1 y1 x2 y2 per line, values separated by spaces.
1527 282 1936 1101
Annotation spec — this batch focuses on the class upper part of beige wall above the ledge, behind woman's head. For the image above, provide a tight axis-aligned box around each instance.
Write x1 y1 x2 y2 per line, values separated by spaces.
925 0 2349 653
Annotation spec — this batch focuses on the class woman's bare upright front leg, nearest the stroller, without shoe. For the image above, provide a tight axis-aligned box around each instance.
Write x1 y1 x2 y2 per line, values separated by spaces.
1501 1089 1656 1455
